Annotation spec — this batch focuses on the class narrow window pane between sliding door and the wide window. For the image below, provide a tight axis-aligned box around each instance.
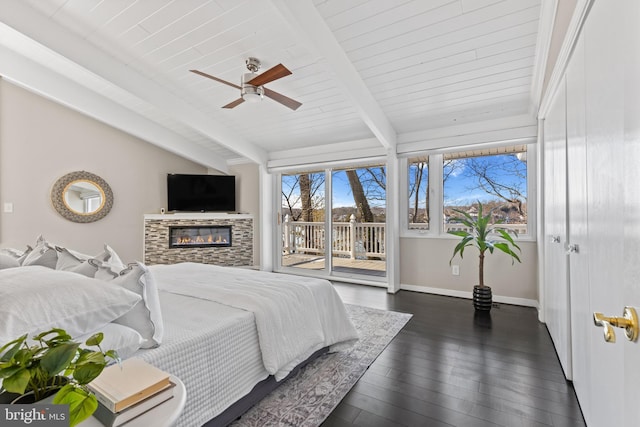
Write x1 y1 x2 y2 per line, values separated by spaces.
408 156 429 230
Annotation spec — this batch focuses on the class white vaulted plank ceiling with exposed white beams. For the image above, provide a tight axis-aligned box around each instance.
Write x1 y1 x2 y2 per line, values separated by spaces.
0 0 544 171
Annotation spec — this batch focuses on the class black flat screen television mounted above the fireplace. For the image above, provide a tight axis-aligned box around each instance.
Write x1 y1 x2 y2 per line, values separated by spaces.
167 173 236 212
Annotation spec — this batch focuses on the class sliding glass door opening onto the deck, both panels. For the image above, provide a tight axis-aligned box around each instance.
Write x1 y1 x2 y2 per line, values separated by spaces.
279 165 386 280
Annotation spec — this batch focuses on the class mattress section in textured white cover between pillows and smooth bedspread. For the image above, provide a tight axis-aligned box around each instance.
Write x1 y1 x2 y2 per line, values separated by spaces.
135 291 269 427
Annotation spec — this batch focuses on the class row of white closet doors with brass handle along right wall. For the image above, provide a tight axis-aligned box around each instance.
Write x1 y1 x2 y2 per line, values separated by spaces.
544 0 640 427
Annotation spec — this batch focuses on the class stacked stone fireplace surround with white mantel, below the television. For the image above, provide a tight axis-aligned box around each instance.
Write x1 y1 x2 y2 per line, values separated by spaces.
144 213 253 266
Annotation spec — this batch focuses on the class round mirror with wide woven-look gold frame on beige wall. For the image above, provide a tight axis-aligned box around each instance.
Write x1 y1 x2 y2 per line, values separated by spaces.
51 171 113 222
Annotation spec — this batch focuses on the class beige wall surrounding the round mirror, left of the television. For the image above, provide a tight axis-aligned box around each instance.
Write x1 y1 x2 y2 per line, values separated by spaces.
0 79 207 262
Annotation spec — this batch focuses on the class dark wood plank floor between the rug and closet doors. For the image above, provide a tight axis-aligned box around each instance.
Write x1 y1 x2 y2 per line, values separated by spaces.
322 283 585 427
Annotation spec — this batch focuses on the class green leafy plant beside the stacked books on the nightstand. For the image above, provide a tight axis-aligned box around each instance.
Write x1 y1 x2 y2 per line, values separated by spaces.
0 329 119 426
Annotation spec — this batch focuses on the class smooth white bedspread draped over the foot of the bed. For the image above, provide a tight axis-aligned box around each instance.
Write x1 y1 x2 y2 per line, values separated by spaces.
149 263 358 380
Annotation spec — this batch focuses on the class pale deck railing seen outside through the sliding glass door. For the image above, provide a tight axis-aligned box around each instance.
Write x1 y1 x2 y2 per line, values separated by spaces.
283 215 386 259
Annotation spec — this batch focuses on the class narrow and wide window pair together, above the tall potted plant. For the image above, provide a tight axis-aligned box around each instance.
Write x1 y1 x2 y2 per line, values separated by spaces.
404 145 535 235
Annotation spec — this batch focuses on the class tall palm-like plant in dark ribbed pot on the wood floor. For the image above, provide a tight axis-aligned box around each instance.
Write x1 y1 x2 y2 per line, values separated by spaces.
448 201 521 311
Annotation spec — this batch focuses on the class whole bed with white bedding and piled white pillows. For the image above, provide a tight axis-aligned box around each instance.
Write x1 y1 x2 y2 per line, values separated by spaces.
0 241 357 427
